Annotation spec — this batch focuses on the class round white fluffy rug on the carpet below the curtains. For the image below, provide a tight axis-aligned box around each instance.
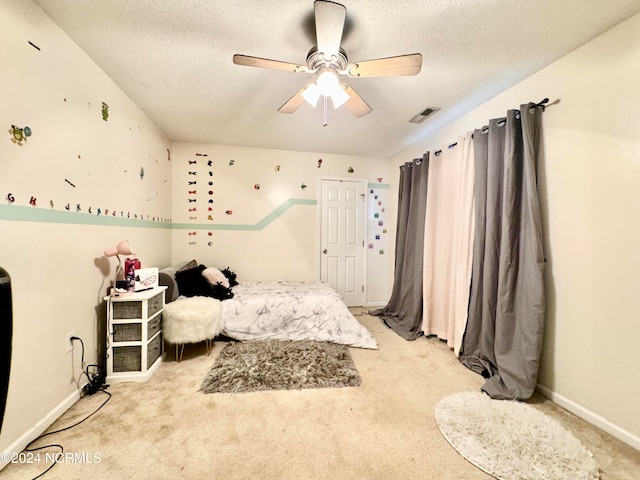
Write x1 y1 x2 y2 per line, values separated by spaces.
435 392 600 480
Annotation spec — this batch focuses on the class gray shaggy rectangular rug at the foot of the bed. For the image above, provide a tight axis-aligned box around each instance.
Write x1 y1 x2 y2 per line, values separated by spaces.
200 340 361 393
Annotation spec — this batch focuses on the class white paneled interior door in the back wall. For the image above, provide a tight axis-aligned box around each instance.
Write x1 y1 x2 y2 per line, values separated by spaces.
320 180 366 307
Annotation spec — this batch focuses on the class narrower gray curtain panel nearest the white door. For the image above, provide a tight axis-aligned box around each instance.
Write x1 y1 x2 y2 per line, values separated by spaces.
369 153 429 340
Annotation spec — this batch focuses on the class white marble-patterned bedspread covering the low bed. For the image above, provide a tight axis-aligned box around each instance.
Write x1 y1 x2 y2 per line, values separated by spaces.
222 282 378 349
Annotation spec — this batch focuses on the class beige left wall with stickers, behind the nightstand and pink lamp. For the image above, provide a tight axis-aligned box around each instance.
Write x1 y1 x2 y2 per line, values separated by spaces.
0 0 171 458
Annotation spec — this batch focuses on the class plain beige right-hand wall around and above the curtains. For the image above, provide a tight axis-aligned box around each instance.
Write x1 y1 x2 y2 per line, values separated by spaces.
394 15 640 448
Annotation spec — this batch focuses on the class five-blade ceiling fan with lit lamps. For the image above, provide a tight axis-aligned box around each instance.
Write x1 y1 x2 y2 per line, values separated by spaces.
233 0 422 120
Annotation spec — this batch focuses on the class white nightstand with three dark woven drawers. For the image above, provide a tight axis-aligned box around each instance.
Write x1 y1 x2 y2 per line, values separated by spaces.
104 287 167 383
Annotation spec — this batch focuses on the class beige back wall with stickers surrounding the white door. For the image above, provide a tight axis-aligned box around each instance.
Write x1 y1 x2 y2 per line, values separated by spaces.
172 143 395 305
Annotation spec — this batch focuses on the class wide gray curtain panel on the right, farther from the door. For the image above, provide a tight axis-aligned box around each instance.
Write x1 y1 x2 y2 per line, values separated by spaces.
460 104 545 400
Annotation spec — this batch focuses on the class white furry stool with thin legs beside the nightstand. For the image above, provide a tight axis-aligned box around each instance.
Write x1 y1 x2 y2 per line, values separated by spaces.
162 297 222 362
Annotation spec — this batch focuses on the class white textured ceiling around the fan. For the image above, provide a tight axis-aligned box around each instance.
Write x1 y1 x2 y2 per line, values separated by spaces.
35 0 640 158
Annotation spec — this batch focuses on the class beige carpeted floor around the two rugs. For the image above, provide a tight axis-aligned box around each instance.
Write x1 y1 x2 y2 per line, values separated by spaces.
0 310 640 480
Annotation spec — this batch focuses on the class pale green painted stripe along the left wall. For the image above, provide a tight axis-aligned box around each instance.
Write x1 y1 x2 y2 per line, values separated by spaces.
0 205 172 229
